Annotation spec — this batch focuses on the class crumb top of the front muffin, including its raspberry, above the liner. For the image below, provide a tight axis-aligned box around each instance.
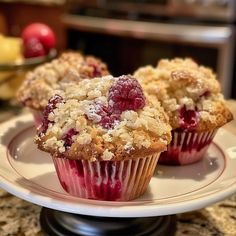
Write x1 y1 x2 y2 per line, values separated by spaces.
35 75 171 161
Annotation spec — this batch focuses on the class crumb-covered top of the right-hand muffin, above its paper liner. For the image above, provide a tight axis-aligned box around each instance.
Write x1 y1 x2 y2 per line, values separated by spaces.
134 58 233 132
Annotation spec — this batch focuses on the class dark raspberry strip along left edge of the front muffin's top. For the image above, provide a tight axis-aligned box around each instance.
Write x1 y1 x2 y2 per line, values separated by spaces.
40 94 63 133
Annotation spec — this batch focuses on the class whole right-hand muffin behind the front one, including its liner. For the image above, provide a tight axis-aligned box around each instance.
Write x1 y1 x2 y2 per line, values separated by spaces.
134 58 233 165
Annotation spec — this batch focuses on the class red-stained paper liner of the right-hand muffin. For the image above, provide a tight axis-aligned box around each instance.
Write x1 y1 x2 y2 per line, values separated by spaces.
158 130 217 165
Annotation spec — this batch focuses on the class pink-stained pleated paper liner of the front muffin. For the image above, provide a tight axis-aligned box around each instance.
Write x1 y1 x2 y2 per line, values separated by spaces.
53 154 159 201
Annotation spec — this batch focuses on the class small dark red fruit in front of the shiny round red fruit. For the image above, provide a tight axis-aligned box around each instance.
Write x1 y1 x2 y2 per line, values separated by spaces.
24 38 47 58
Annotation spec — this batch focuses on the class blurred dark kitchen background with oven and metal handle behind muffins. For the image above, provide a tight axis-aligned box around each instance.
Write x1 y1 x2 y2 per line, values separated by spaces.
0 0 236 98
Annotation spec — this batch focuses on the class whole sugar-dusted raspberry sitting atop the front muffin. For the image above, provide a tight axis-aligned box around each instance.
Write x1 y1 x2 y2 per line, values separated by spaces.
109 75 145 112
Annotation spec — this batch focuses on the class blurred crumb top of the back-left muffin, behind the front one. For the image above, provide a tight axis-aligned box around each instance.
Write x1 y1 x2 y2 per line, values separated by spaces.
17 52 109 110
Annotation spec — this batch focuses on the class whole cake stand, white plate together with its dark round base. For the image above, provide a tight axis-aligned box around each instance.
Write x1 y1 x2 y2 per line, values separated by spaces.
0 114 236 236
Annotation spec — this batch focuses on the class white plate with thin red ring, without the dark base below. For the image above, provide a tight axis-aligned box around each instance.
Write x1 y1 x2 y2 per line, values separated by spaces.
0 115 236 217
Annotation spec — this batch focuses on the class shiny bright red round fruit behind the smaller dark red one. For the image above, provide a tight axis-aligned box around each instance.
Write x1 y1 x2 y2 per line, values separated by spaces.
21 23 56 53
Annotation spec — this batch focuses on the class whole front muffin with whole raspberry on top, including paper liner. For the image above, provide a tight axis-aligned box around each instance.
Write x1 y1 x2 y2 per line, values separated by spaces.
35 75 171 201
